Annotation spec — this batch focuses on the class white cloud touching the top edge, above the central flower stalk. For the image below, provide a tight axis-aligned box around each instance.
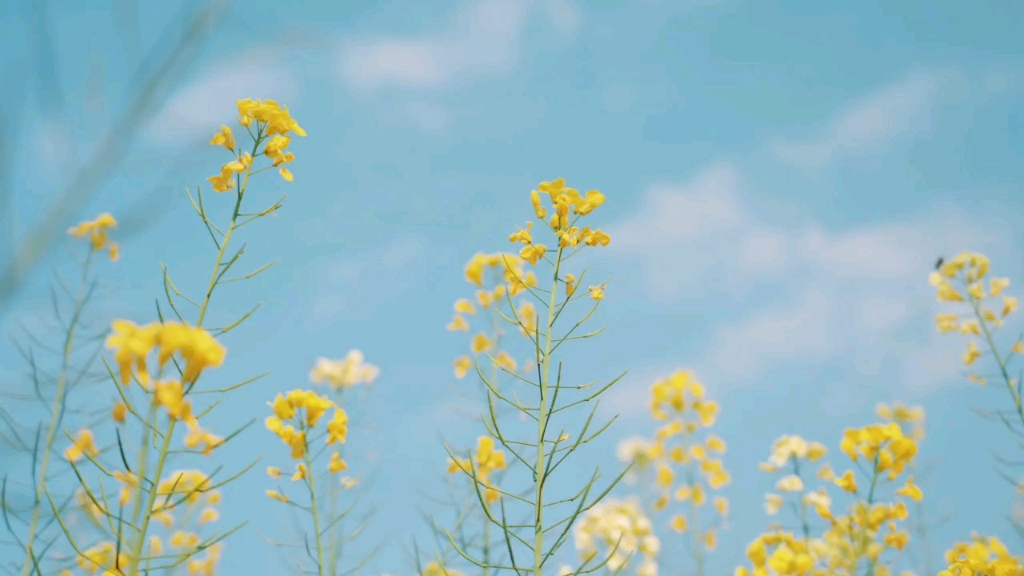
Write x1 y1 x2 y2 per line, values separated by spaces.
339 0 580 89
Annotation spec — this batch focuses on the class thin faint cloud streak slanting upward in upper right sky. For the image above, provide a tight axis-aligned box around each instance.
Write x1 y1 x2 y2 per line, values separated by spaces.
771 73 943 168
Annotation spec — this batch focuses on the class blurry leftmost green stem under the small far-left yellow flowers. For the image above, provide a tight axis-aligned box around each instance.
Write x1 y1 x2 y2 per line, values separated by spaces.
22 246 95 576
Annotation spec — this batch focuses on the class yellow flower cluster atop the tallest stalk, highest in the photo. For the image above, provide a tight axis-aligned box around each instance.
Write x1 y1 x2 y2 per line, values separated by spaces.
207 98 306 192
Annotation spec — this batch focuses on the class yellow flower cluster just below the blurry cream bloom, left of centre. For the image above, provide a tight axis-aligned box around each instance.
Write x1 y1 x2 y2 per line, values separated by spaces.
265 389 348 502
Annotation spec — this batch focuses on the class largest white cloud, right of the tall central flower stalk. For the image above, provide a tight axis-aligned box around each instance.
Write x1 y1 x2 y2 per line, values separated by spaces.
610 158 1012 410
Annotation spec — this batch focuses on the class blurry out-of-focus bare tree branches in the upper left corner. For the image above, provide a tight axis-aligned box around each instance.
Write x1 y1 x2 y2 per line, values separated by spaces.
0 0 230 314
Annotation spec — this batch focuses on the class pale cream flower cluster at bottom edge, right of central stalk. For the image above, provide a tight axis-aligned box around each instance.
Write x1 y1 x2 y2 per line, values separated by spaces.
573 499 662 576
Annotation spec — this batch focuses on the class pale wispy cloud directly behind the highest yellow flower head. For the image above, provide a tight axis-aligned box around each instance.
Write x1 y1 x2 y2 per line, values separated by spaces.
146 50 299 146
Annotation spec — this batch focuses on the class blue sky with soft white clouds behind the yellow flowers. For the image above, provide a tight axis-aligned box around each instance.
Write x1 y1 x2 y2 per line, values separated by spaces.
0 0 1024 574
